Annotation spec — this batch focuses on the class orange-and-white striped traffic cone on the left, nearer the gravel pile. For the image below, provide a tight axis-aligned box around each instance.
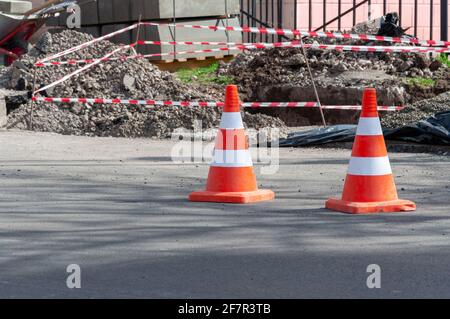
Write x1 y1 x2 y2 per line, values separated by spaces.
189 85 275 204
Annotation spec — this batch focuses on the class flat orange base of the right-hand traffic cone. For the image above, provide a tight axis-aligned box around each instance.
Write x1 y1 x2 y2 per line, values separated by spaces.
325 199 416 214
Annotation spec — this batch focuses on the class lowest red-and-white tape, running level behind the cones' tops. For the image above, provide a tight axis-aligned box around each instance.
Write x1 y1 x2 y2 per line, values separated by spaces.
32 96 404 111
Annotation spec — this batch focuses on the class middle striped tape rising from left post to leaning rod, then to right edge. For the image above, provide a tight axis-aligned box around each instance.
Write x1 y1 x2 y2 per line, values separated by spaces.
35 41 450 67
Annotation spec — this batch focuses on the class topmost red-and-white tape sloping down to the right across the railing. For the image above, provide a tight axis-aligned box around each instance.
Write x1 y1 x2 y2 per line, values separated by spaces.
141 22 450 46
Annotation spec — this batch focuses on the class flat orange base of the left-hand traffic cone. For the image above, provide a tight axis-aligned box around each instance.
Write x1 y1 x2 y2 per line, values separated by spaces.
189 189 275 204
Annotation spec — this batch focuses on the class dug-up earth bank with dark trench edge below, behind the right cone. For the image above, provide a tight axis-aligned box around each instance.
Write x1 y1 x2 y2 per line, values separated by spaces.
225 49 450 127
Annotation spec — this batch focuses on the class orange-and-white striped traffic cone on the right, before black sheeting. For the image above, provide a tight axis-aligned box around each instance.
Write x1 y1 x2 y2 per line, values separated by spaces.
326 89 416 214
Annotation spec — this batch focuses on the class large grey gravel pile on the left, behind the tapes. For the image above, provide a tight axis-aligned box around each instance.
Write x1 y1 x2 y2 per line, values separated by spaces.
0 30 284 138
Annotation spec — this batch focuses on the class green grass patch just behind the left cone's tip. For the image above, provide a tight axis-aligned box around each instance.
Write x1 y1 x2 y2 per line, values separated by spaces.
176 63 233 85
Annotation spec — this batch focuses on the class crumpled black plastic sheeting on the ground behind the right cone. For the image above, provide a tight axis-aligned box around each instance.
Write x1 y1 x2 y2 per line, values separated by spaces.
280 111 450 147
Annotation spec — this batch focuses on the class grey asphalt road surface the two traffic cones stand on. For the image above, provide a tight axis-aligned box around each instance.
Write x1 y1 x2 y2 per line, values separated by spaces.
0 131 450 298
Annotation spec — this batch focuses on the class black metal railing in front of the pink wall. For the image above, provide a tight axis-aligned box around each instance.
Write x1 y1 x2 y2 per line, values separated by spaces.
237 0 449 42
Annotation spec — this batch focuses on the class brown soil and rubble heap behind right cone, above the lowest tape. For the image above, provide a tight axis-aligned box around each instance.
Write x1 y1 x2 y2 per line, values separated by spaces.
220 46 450 100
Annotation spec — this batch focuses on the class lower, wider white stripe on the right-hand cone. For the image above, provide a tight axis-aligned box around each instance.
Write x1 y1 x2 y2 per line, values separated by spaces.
348 156 392 176
